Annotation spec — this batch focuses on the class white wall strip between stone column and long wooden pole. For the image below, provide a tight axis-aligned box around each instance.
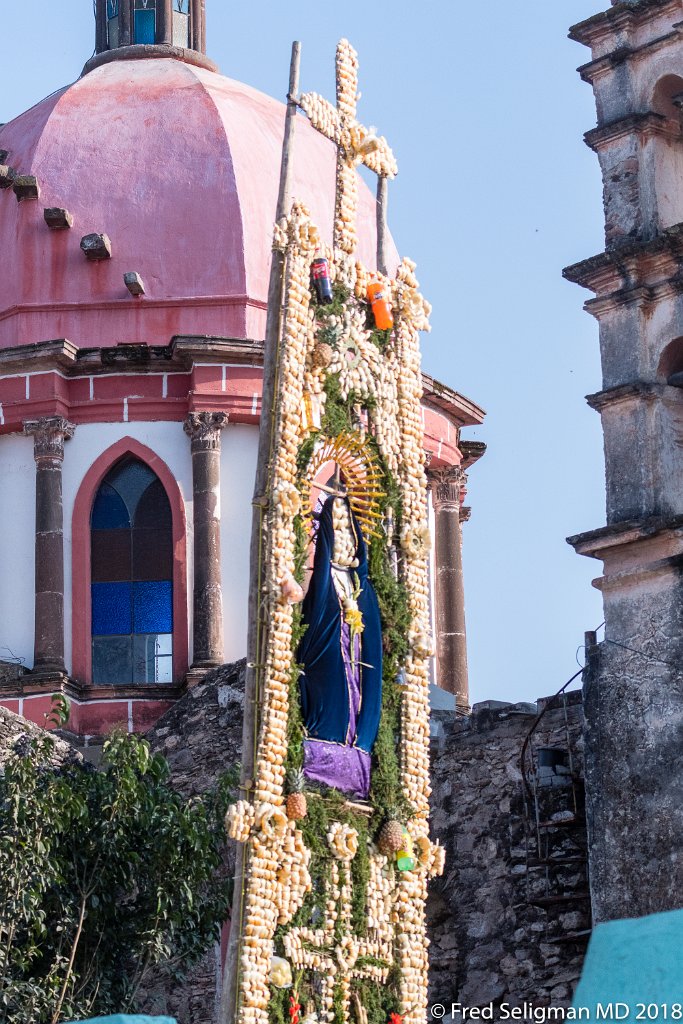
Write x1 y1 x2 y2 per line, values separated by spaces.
220 424 258 662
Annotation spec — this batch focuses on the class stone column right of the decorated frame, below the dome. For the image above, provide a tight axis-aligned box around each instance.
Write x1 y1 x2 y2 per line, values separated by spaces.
429 466 470 715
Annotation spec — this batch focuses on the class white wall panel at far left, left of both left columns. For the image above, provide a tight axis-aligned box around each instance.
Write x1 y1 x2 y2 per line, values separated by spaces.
0 434 36 668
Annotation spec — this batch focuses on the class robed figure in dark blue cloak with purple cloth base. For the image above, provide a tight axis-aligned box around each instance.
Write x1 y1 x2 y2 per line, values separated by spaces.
297 497 382 799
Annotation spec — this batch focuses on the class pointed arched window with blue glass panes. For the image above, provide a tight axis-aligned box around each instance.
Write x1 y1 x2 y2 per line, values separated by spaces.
90 457 173 685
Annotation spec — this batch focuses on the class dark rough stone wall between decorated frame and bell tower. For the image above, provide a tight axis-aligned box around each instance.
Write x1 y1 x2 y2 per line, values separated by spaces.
429 692 590 1007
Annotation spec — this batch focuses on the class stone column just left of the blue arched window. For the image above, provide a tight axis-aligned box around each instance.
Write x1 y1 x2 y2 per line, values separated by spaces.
24 416 76 675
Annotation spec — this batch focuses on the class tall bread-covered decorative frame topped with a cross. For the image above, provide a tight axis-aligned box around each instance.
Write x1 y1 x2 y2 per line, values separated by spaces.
227 40 443 1024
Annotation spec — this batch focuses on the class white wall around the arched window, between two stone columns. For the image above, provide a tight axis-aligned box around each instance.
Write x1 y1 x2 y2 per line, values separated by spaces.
62 423 193 671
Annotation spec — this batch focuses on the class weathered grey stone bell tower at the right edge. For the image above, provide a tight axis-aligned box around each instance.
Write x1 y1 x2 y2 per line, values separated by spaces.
564 0 683 921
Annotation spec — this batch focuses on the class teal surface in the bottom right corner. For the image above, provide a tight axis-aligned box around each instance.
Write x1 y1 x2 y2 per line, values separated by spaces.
573 910 683 1024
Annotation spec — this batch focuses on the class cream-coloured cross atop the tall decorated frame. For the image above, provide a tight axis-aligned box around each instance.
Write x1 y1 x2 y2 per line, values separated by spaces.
299 39 398 256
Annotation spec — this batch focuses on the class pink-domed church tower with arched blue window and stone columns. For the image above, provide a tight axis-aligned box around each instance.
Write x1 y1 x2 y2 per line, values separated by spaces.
0 0 484 742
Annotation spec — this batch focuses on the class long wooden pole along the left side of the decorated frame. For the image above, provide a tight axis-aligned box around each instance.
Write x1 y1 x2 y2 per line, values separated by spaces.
220 42 301 1024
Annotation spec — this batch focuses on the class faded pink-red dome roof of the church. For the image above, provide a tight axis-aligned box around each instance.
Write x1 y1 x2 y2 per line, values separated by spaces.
0 57 395 356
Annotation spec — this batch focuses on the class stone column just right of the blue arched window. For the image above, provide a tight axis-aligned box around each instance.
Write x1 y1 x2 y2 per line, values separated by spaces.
184 413 227 669
